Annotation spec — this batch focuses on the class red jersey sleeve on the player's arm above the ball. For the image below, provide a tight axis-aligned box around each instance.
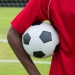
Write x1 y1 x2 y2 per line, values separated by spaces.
11 0 45 34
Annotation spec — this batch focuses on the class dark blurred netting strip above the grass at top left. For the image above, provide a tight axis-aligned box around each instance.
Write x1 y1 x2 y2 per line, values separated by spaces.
0 0 28 7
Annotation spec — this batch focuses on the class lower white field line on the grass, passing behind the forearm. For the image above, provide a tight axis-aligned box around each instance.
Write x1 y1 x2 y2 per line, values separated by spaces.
0 60 51 64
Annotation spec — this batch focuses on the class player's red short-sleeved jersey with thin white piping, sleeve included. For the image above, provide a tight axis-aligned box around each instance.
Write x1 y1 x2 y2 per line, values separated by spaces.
11 0 75 75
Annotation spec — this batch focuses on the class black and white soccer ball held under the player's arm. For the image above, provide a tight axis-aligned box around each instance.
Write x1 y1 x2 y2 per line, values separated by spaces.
22 22 59 58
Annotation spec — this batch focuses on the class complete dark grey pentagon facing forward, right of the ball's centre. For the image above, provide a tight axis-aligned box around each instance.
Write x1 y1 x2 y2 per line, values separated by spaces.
39 31 52 43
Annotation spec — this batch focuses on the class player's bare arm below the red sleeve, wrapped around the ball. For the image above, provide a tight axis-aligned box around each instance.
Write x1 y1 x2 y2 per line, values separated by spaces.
7 26 41 75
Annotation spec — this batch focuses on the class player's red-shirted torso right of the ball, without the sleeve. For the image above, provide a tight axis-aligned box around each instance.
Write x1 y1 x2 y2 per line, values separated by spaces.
49 0 75 75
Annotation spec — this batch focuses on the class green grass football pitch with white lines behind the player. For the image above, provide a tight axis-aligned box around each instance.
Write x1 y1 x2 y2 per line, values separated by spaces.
0 7 51 75
